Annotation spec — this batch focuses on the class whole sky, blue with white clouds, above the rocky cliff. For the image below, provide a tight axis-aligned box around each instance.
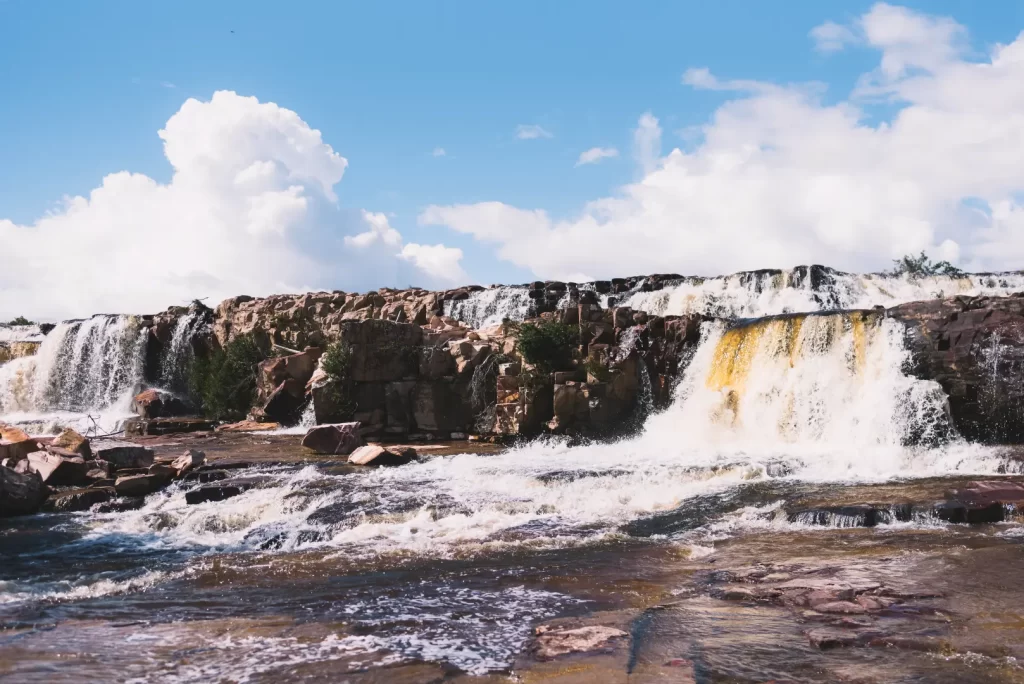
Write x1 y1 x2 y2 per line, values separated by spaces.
0 0 1024 320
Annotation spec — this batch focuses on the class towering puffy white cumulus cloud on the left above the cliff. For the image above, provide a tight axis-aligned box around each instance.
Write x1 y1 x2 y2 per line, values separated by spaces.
0 91 464 319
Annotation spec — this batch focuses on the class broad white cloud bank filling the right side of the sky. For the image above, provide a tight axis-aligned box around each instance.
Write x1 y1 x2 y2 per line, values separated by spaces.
420 4 1024 277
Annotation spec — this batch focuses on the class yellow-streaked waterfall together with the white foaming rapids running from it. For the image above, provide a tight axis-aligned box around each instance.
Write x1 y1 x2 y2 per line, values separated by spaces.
81 314 1001 557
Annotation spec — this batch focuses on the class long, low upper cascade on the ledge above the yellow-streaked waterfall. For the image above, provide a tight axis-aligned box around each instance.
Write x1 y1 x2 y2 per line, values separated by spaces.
621 266 1024 318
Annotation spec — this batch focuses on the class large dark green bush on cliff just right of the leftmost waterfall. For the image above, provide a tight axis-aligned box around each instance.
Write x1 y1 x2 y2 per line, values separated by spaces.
188 335 266 420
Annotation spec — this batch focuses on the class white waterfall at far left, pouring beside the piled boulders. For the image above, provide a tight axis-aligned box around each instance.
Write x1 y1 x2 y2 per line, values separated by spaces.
0 315 147 432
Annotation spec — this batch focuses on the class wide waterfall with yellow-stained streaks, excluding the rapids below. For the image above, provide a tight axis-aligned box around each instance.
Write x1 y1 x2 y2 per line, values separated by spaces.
654 311 951 450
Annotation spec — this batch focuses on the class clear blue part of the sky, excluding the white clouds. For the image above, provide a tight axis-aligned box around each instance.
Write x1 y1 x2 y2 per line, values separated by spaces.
0 0 1024 317
